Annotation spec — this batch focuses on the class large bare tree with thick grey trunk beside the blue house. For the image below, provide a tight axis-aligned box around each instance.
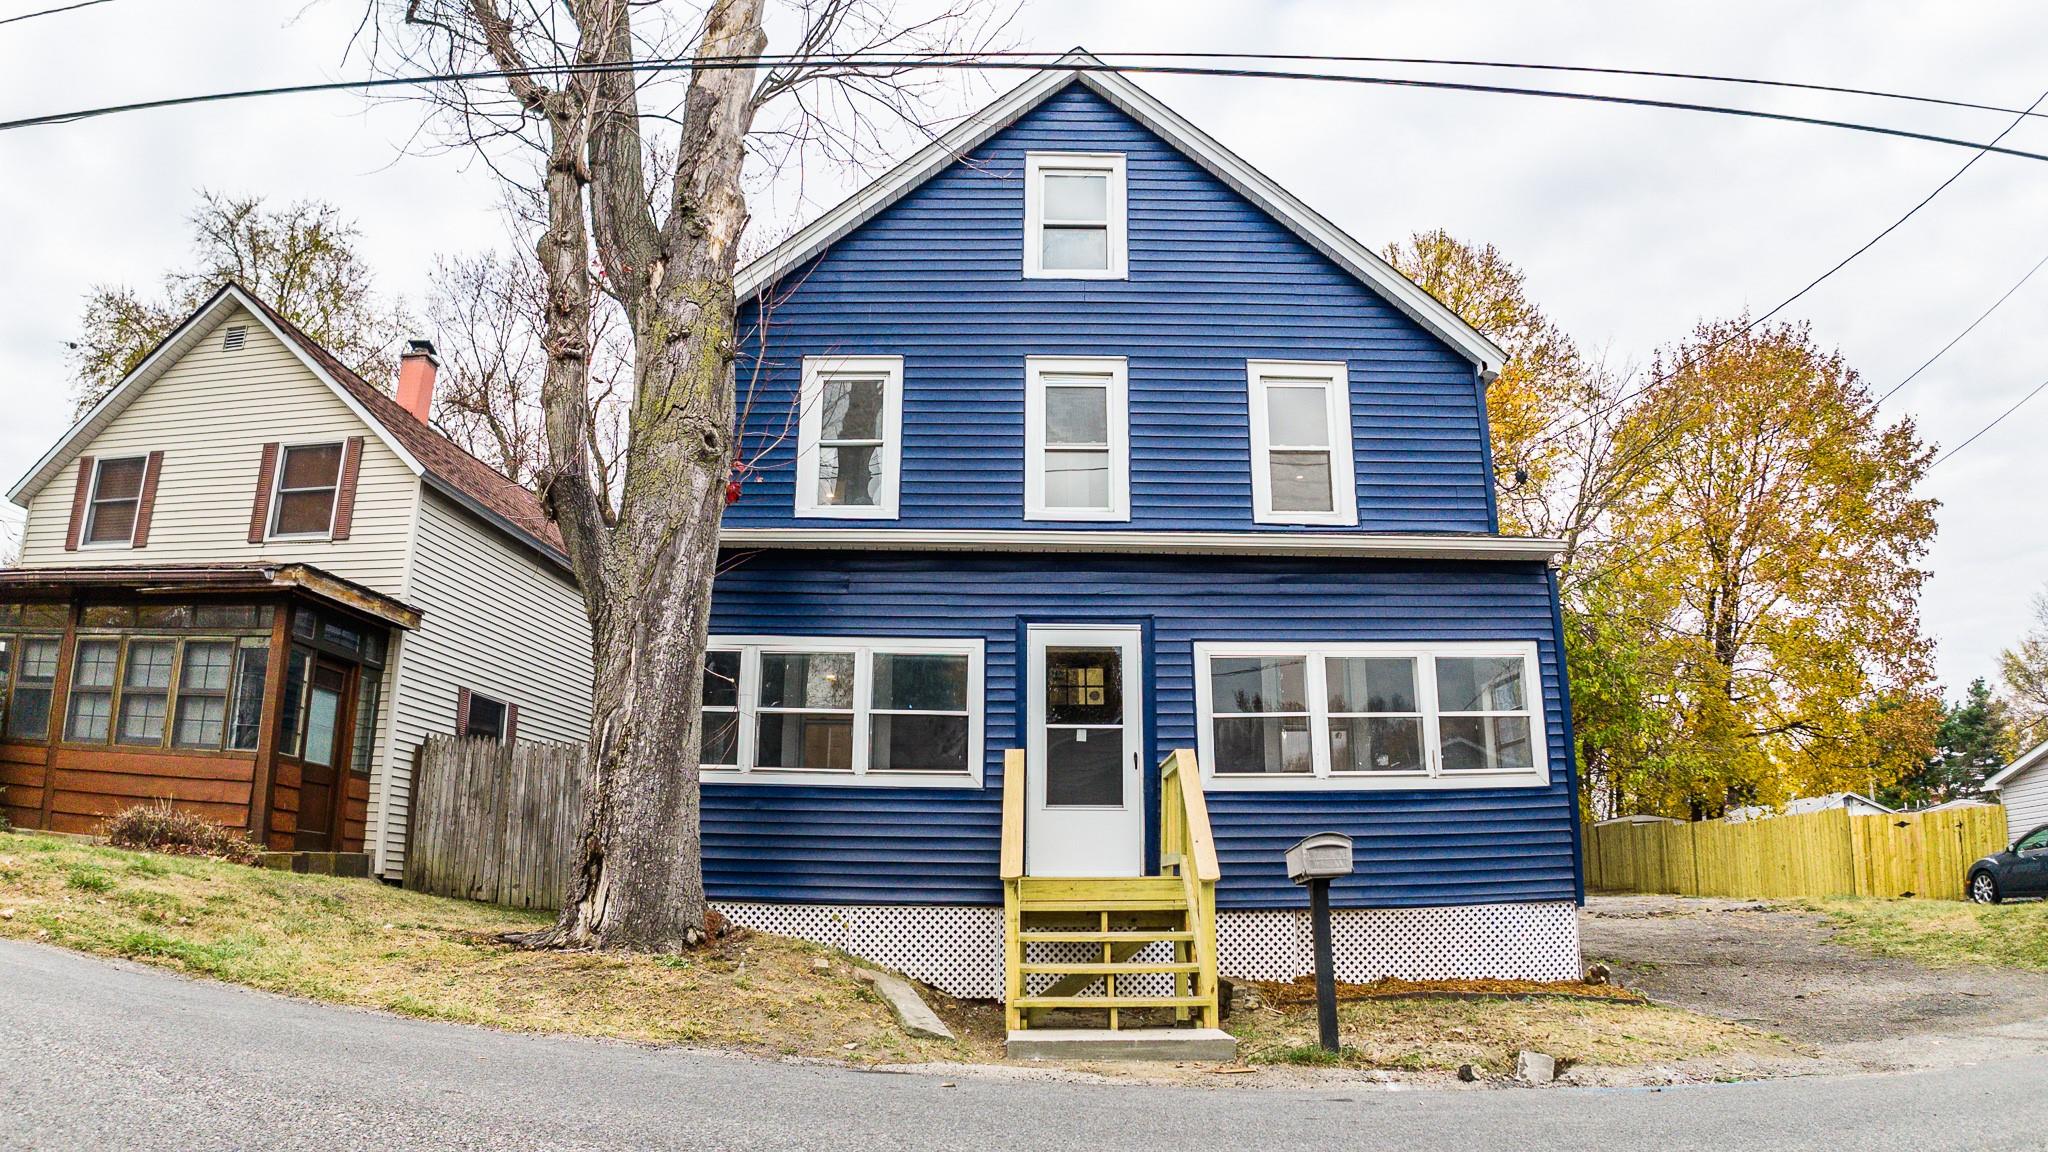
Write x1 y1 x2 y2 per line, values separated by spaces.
373 0 1001 951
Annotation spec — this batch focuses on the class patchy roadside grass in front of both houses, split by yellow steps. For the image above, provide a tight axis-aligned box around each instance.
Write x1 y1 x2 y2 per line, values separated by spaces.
0 832 1792 1072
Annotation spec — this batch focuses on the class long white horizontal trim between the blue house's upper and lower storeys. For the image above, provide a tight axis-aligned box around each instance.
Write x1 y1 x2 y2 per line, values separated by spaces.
719 527 1565 562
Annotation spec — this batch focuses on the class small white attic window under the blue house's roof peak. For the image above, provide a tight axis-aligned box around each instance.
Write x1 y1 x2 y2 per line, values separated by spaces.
1024 152 1128 281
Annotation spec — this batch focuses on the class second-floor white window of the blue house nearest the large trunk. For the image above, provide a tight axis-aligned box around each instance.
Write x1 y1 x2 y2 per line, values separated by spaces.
797 357 903 521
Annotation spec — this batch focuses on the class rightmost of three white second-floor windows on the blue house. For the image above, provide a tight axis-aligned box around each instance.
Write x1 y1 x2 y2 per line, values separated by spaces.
1245 361 1358 525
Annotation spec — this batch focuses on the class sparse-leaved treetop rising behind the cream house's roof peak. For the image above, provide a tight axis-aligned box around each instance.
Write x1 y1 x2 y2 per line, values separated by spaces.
72 191 406 412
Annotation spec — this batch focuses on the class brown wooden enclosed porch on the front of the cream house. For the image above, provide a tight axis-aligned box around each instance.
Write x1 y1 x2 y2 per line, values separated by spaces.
0 564 420 853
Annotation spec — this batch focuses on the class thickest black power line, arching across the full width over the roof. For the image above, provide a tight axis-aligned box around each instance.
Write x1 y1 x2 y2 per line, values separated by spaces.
0 53 2048 160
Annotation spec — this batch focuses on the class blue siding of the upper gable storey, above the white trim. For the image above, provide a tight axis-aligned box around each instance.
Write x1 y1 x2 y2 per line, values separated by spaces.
725 86 1493 531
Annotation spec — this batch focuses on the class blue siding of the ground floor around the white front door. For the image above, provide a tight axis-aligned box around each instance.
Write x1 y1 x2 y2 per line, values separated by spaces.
705 551 1577 908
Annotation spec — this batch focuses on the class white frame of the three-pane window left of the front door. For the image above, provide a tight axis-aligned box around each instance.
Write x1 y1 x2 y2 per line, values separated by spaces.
700 635 989 787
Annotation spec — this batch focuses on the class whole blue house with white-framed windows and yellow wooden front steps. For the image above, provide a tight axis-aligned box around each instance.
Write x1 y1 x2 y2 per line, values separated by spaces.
705 53 1581 1015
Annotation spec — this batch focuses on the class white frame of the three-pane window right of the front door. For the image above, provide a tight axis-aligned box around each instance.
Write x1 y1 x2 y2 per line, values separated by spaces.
1194 640 1550 791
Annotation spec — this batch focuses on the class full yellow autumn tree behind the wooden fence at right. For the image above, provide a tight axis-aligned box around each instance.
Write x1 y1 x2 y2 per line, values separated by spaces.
1575 318 1942 818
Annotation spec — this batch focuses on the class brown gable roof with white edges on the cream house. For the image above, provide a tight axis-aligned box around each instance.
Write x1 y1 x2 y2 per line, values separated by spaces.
8 283 569 568
